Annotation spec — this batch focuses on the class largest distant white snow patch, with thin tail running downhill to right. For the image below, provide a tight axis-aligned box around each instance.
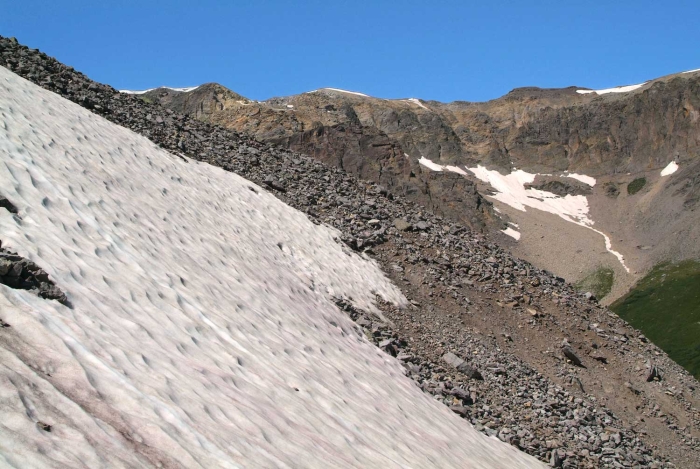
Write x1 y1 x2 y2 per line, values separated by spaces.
467 165 629 272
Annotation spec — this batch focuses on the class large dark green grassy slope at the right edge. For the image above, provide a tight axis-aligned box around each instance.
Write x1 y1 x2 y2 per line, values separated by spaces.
610 260 700 378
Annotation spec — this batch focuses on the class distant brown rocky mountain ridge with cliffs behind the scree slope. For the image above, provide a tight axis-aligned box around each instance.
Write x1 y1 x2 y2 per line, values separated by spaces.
138 72 700 302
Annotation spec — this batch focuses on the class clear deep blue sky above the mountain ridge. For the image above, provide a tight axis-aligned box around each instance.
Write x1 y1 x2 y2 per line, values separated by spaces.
0 0 700 101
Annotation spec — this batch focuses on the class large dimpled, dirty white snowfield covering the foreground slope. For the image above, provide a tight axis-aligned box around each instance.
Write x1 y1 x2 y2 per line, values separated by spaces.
0 67 542 468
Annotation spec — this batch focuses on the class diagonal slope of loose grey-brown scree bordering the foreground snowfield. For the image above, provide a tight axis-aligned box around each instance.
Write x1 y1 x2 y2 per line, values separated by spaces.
0 34 700 467
